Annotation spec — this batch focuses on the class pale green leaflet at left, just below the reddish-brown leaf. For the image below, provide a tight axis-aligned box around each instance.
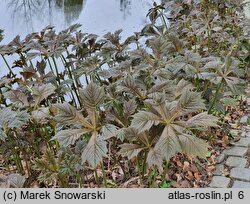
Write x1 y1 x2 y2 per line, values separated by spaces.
32 84 56 106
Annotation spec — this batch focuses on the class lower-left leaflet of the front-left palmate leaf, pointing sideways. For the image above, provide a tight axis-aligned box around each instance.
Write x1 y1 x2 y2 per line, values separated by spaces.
52 129 91 147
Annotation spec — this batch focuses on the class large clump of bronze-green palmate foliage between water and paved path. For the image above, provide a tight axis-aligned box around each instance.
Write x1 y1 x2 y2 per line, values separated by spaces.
0 0 250 187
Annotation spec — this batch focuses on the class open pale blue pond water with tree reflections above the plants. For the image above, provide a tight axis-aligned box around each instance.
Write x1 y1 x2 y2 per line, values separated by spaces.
0 0 160 43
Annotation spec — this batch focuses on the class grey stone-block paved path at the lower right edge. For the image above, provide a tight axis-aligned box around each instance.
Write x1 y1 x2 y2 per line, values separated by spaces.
210 88 250 188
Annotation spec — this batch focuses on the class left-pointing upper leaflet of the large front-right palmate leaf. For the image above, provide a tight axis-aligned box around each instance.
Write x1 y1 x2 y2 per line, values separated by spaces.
131 111 160 132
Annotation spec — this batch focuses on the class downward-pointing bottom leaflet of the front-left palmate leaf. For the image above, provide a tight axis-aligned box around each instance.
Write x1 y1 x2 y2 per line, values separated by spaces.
81 134 108 168
